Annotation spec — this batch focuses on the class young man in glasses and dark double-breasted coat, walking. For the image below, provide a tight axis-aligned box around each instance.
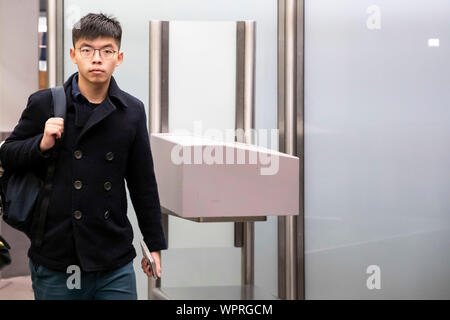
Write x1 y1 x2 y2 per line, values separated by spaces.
0 14 167 299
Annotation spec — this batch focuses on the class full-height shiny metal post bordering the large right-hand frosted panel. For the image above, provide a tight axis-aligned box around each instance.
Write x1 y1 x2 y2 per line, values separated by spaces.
278 0 304 300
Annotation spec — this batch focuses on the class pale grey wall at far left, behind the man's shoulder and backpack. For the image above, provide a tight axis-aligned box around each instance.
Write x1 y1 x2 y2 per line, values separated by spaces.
0 0 39 278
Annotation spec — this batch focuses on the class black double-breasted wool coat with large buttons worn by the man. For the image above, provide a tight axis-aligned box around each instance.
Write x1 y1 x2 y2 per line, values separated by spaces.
0 73 167 272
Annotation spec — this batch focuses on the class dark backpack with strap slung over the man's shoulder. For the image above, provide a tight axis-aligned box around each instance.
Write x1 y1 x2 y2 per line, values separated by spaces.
0 86 66 246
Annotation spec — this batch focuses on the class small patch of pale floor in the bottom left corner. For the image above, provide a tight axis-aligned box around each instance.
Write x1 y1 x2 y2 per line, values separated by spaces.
0 276 34 300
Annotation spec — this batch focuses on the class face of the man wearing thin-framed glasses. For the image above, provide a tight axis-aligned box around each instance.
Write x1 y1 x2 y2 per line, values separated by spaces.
70 38 123 84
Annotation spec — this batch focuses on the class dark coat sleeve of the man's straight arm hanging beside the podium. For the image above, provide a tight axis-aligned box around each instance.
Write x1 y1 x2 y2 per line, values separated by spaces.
125 102 167 251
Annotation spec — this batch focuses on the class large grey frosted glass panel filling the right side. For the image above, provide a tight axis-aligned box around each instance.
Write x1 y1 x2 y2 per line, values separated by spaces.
305 0 450 299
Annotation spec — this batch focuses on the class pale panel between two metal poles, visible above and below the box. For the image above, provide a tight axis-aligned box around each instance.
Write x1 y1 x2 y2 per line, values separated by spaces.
169 21 236 248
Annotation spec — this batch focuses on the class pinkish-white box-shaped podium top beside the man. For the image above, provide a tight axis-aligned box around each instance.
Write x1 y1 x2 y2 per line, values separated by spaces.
150 133 299 221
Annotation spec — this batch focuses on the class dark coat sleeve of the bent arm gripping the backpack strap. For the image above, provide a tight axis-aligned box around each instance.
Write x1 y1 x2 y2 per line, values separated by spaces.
0 94 51 171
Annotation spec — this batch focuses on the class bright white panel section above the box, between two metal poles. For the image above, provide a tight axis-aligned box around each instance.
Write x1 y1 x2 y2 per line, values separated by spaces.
169 21 236 136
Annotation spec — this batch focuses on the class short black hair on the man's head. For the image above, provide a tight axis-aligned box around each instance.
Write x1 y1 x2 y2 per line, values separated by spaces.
72 13 122 49
